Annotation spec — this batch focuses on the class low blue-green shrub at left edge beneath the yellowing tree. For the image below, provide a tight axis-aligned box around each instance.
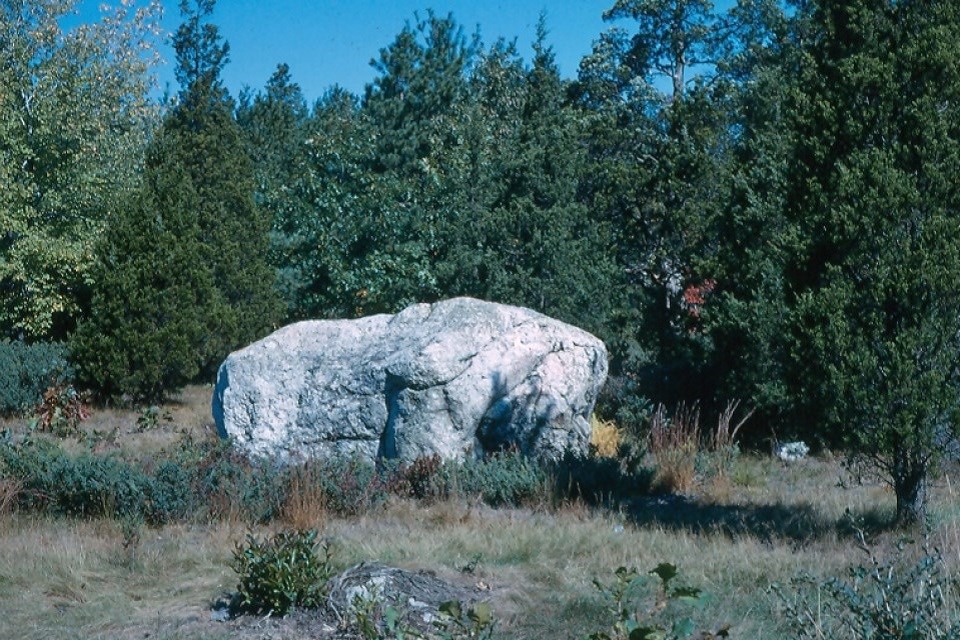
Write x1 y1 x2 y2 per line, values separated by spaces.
0 340 73 415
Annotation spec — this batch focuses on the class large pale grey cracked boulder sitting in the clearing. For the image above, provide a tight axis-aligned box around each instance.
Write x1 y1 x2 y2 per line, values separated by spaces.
213 298 607 462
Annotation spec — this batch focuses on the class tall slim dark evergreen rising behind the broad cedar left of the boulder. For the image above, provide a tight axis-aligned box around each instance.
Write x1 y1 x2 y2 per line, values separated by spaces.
161 0 278 362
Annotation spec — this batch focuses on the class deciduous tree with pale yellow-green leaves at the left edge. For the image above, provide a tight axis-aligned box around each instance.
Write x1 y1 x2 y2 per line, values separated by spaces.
0 0 159 339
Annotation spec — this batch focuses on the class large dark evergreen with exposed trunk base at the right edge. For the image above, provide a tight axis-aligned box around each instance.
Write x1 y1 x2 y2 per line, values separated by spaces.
788 0 960 523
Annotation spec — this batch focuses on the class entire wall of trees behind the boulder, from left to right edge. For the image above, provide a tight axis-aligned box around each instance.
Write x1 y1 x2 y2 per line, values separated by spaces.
7 0 960 521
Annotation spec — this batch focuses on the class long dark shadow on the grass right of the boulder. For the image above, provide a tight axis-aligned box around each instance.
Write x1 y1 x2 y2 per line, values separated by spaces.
621 495 894 543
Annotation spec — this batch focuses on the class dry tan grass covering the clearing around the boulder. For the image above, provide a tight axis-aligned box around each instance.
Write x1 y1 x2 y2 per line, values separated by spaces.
0 387 960 639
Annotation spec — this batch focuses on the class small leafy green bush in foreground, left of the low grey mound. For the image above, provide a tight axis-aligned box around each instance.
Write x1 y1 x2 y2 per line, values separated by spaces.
231 530 333 616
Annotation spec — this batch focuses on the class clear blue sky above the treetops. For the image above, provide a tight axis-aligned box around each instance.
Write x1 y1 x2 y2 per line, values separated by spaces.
78 0 729 102
